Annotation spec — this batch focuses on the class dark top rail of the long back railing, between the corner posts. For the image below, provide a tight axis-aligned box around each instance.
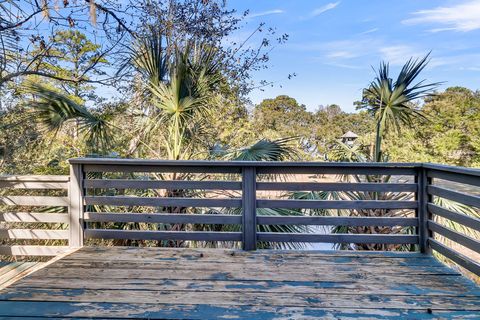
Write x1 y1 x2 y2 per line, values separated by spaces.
69 158 422 168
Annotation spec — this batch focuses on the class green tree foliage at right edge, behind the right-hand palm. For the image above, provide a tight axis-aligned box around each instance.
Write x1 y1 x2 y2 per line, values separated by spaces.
385 87 480 167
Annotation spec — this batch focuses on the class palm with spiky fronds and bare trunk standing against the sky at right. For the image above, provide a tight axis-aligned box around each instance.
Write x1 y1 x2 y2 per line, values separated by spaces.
360 54 440 162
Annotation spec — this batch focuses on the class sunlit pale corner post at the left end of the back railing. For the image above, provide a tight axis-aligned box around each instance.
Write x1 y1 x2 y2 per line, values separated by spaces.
68 164 84 248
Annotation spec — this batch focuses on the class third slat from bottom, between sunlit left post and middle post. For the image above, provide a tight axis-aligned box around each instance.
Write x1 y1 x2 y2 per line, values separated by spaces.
84 196 242 208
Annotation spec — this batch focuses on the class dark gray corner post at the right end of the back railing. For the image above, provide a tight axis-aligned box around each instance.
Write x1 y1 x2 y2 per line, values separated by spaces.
416 167 432 253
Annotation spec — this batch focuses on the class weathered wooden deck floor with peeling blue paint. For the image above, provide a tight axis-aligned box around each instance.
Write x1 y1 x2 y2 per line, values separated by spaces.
0 247 480 319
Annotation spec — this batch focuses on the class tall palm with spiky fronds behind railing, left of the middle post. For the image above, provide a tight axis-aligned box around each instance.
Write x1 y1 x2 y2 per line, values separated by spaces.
130 29 222 160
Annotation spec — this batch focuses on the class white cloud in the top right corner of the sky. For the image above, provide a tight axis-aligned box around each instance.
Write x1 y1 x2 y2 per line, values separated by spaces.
402 0 480 32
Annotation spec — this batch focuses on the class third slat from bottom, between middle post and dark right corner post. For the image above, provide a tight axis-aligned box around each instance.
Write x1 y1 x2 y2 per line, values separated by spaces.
257 200 418 209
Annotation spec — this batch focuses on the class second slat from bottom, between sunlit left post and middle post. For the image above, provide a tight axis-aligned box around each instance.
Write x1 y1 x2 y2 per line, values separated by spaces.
84 212 242 224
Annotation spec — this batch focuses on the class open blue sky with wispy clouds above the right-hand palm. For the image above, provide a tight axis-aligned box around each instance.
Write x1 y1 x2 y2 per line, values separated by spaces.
227 0 480 111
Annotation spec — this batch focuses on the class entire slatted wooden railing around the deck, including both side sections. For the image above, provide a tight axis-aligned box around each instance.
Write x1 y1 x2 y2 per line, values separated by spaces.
0 159 480 274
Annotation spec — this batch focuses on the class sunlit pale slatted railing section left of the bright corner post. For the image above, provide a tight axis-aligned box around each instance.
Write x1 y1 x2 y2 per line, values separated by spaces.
0 175 71 256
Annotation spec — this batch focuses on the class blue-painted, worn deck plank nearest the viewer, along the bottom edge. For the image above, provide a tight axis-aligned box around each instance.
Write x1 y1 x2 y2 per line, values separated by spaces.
0 301 478 320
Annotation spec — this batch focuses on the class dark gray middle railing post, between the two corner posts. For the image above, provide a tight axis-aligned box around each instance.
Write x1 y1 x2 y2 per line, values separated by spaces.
242 167 257 250
